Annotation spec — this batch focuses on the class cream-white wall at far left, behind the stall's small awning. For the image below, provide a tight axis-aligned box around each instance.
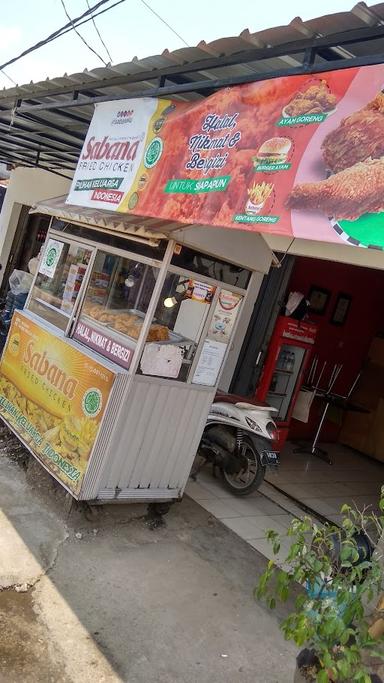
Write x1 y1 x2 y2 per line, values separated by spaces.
0 166 71 284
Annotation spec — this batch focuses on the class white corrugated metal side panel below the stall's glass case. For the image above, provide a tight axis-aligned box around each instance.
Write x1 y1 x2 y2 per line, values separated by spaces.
95 378 215 498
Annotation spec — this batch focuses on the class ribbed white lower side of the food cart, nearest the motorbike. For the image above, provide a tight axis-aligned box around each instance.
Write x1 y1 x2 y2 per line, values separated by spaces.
83 376 216 501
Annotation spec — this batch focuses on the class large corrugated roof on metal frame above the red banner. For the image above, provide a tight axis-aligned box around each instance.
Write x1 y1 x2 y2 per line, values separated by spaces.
0 2 384 176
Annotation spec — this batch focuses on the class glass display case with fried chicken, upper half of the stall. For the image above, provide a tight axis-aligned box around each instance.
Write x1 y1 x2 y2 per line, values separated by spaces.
27 222 251 383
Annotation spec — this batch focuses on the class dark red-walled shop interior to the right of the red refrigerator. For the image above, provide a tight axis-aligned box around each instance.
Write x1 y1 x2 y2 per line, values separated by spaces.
267 257 384 522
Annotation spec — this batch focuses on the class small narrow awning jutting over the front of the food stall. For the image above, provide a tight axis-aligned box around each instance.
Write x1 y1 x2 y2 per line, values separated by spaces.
30 195 190 244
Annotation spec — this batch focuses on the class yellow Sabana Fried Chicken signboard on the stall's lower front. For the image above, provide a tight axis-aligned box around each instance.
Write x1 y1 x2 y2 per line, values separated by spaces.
0 312 115 495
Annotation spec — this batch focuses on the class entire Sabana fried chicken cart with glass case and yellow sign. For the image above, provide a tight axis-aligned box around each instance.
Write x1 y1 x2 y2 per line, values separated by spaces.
0 207 253 502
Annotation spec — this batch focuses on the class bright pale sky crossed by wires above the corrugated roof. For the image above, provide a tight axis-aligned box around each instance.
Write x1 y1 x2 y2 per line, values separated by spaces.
0 0 374 88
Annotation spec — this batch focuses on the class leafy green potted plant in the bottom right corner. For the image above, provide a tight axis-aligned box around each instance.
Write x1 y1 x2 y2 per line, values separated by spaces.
255 492 384 683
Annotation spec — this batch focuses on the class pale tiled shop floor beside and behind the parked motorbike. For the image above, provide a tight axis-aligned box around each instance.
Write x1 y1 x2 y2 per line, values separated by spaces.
186 444 384 561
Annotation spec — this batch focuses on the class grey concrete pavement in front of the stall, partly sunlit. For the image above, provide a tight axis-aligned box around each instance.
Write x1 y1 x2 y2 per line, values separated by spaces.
0 446 295 683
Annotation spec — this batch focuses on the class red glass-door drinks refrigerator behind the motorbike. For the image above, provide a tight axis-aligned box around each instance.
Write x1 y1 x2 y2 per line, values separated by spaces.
256 316 317 451
